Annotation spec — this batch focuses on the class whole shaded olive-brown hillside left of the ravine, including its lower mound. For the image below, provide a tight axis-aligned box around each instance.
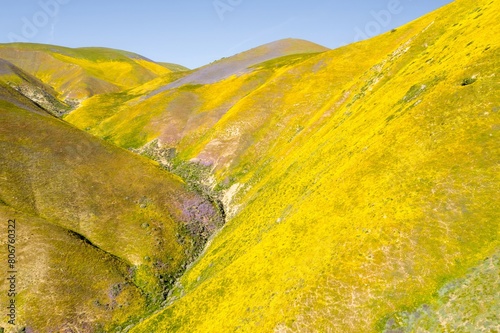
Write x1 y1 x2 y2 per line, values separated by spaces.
0 91 221 331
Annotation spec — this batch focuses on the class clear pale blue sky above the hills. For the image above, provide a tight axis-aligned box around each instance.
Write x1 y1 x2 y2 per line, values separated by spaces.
0 0 451 68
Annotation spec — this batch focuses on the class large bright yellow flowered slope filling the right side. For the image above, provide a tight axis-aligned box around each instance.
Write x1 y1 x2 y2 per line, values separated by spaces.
130 0 500 332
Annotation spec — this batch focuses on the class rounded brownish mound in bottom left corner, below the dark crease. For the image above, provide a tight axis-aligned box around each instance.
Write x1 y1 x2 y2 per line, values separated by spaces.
0 205 147 332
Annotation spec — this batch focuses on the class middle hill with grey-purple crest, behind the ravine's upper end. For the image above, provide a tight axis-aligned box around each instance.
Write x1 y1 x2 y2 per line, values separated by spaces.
65 39 327 148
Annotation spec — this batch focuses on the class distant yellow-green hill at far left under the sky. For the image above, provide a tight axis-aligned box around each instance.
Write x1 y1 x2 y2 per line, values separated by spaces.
0 44 171 100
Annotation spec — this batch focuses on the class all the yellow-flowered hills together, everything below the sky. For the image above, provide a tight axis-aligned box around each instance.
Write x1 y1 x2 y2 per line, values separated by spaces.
0 0 500 333
